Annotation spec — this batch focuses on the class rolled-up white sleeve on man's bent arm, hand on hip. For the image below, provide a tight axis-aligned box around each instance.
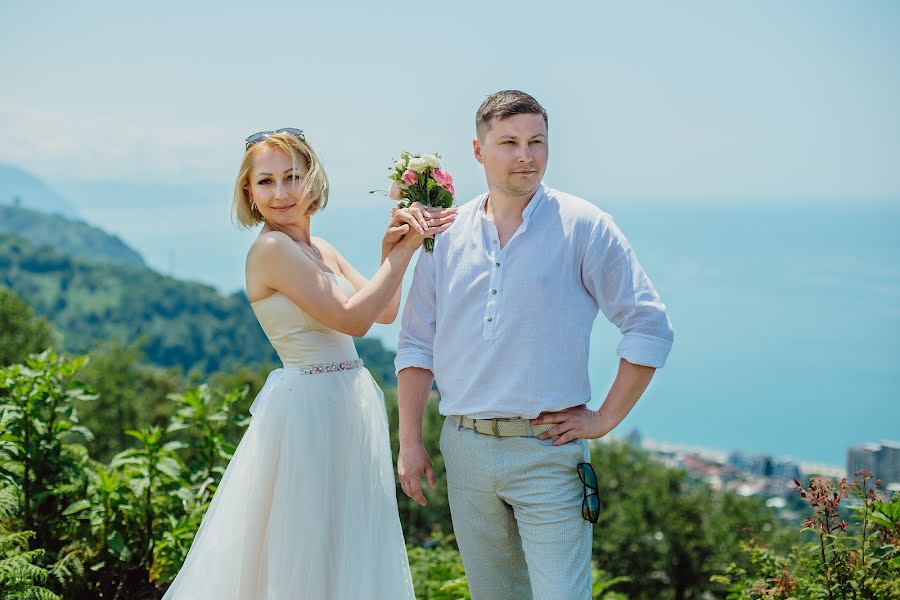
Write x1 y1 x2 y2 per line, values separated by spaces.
582 213 674 368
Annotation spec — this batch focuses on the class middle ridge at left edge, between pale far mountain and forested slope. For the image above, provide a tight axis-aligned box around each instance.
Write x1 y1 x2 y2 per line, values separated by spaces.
0 206 145 267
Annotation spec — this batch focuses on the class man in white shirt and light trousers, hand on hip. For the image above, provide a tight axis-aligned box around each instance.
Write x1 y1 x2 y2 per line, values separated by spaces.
396 91 672 600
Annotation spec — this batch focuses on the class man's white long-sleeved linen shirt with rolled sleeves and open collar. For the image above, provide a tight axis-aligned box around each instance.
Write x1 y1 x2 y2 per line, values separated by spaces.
394 183 673 419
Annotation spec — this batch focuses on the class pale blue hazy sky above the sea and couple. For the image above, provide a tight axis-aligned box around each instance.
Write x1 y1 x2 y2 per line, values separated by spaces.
0 0 900 202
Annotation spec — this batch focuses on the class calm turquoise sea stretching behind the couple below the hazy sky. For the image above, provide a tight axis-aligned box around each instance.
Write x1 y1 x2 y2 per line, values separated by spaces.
56 182 900 466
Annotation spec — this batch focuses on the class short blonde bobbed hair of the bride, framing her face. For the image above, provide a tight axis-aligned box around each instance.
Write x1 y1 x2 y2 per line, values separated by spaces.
231 133 328 229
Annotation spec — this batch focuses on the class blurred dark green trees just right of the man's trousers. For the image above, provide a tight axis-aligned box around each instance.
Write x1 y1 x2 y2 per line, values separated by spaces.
591 441 778 600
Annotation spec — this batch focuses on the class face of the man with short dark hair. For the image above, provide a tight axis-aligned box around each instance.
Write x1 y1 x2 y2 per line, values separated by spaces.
472 115 549 196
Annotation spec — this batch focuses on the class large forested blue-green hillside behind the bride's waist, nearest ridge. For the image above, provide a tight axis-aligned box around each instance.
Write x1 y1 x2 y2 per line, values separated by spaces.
0 233 396 385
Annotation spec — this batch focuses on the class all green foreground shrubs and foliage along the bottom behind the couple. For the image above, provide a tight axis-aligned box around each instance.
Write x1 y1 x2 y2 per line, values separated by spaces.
0 344 900 600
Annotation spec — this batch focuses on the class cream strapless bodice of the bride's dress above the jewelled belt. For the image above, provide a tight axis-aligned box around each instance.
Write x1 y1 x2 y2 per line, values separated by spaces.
250 274 359 367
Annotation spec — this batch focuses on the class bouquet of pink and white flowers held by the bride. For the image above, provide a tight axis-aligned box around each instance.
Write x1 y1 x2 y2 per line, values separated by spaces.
378 152 456 252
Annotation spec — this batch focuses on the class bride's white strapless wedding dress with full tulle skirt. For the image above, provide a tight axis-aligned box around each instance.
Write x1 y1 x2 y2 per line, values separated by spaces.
164 276 415 600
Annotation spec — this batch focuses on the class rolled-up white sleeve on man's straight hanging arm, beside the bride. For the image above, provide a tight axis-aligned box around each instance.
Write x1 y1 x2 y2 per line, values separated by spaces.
394 250 437 373
